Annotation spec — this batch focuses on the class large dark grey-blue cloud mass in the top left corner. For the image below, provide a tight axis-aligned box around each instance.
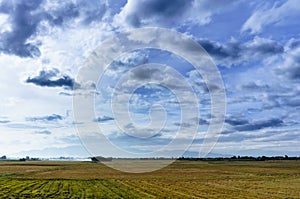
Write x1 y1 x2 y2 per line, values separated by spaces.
0 0 106 57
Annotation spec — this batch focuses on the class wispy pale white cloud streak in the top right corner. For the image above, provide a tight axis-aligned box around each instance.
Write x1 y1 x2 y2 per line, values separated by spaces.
241 0 300 34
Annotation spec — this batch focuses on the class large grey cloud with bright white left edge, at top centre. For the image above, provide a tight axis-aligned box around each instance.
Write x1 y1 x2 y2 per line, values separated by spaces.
115 0 237 27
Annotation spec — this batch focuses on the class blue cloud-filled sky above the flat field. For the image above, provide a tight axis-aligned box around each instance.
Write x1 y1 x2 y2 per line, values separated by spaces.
0 0 300 157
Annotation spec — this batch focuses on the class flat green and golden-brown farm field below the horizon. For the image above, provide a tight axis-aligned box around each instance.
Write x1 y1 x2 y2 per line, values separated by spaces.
0 160 300 198
